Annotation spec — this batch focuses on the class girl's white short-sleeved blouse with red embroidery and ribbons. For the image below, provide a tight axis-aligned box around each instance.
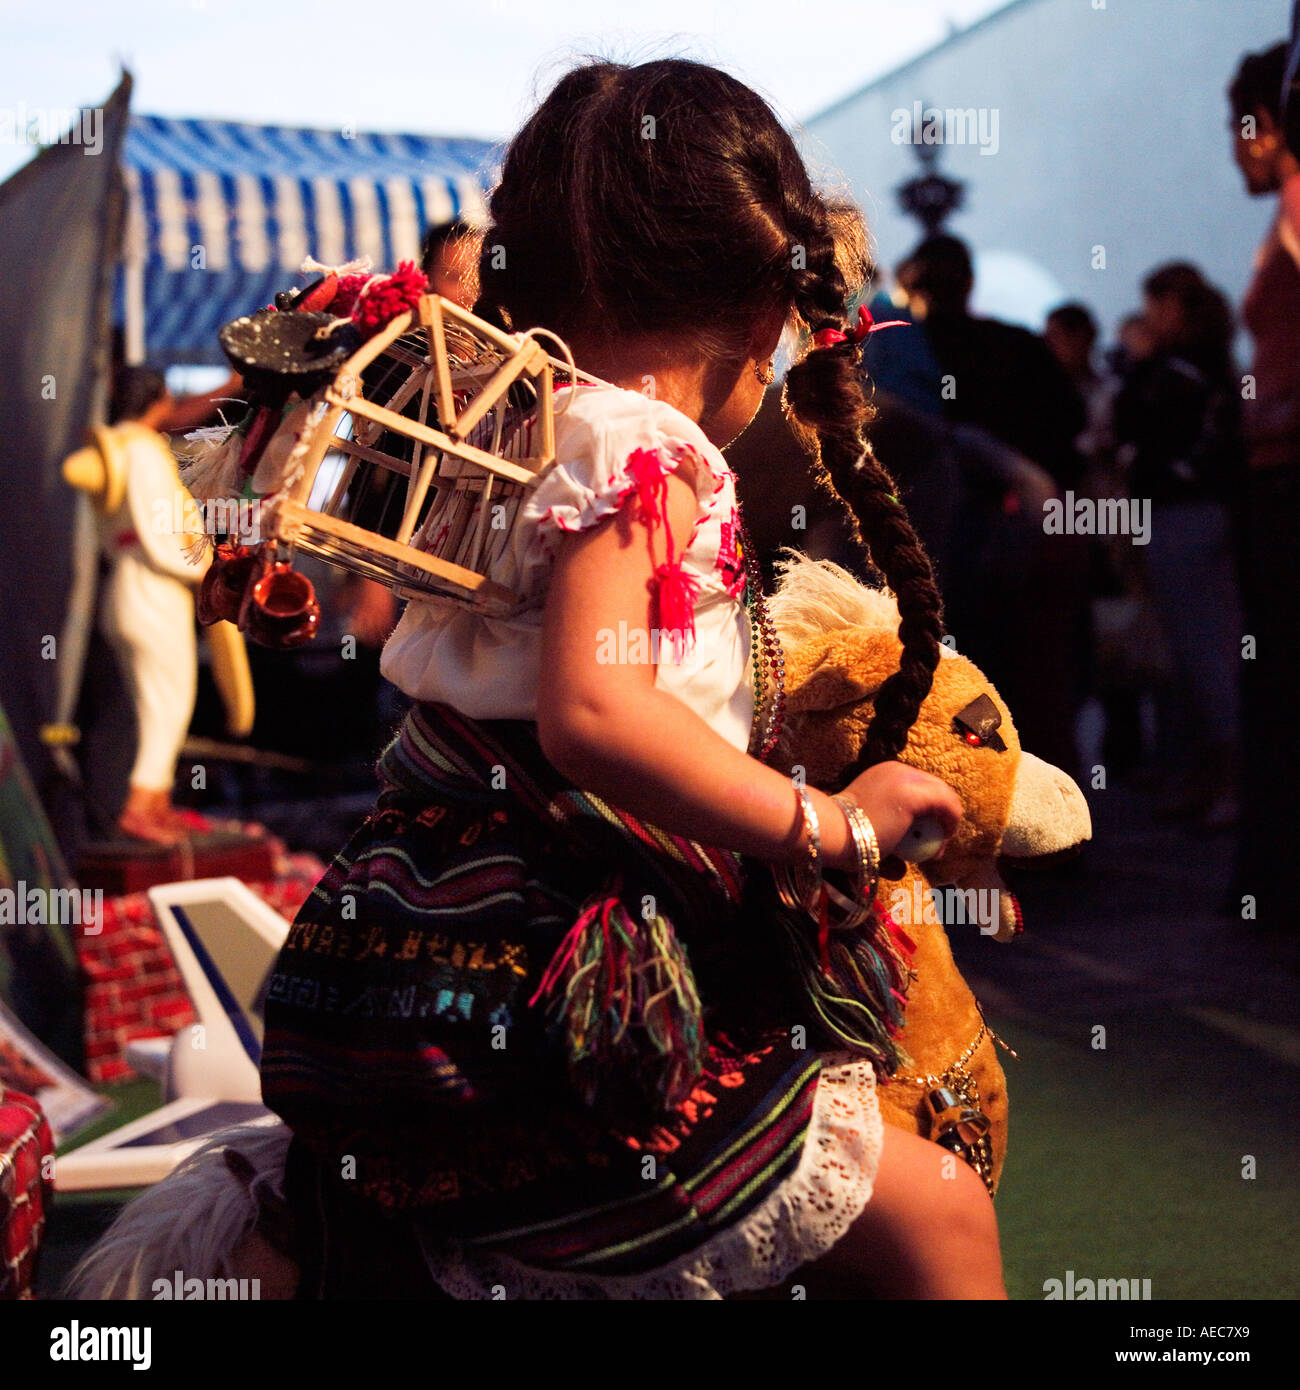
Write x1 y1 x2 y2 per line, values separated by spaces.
381 385 754 749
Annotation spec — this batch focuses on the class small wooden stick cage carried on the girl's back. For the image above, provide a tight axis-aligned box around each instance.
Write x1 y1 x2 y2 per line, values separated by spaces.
261 295 595 614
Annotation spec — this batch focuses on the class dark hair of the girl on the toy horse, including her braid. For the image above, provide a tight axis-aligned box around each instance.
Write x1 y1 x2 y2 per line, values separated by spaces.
474 58 943 773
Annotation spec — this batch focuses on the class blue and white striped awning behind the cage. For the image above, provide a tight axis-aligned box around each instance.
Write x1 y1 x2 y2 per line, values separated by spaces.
120 115 498 364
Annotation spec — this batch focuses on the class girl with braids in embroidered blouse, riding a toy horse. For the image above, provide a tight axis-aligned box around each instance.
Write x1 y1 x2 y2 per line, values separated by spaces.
263 61 1004 1298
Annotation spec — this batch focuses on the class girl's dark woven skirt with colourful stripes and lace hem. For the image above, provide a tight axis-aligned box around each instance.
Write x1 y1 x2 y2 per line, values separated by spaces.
263 706 879 1297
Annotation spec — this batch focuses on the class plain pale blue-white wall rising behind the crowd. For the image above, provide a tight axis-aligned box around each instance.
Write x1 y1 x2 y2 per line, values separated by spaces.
805 0 1290 340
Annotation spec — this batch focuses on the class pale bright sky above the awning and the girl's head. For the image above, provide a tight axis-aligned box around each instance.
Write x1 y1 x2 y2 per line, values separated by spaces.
0 0 1007 178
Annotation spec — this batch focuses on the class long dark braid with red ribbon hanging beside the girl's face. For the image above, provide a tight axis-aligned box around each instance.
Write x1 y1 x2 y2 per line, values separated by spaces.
784 205 943 776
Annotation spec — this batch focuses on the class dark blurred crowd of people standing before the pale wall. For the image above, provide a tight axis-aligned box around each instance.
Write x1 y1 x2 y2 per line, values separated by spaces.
730 43 1300 924
